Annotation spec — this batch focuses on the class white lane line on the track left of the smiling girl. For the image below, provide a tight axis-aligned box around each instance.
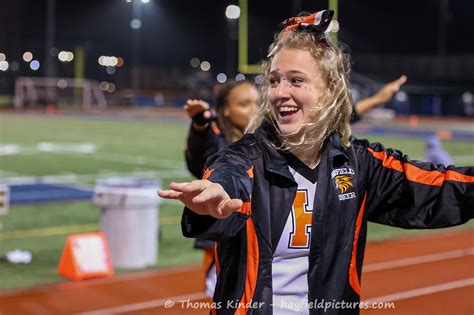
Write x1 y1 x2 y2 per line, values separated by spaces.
78 293 207 315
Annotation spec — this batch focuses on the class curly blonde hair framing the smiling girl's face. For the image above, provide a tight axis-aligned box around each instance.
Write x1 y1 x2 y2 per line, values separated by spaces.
247 31 352 151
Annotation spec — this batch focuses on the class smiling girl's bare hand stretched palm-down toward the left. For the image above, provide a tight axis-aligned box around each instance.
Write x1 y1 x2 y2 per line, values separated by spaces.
158 180 243 219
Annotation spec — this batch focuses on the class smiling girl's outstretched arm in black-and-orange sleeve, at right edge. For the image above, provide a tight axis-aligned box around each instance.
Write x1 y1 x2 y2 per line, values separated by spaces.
361 142 474 228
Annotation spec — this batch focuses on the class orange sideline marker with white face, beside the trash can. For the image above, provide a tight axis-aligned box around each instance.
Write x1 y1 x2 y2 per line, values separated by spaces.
58 232 114 281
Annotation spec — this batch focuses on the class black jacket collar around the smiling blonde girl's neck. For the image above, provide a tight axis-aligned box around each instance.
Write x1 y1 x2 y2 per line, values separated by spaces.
255 122 349 181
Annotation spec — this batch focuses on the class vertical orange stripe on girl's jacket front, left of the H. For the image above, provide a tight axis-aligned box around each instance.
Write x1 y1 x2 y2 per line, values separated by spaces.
235 219 259 315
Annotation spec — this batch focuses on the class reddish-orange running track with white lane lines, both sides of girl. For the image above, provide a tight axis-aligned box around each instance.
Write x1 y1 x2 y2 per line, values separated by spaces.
0 230 474 315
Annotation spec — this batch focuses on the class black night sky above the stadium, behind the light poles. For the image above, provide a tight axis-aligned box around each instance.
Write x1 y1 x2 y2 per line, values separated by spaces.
0 0 474 79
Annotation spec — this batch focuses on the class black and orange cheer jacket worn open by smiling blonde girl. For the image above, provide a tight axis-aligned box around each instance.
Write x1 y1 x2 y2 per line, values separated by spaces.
182 127 474 314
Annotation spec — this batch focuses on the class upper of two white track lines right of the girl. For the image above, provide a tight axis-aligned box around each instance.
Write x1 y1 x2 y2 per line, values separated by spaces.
362 247 474 272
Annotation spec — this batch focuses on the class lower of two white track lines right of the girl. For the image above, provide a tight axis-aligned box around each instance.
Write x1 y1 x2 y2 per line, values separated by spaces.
363 278 474 303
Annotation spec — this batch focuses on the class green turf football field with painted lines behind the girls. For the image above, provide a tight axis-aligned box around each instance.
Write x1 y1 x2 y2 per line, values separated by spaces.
0 114 474 290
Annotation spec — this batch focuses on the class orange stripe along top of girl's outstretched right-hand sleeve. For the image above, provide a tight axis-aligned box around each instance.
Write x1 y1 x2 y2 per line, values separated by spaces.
367 148 474 186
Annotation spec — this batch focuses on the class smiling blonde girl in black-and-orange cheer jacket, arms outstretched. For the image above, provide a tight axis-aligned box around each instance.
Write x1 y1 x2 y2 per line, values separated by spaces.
159 11 474 314
